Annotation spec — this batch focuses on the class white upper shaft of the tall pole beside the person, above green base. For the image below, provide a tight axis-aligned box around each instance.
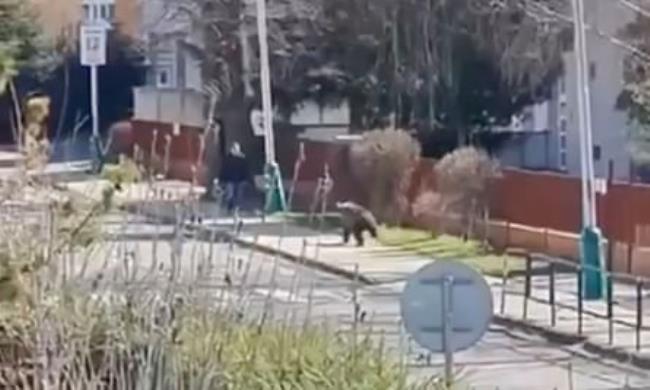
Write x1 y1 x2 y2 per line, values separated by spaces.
257 0 275 164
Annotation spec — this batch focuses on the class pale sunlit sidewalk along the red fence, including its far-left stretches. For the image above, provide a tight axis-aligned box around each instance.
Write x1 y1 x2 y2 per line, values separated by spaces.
63 178 650 366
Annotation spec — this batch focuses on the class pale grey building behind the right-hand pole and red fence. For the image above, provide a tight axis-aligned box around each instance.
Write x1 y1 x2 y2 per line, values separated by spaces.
499 0 635 180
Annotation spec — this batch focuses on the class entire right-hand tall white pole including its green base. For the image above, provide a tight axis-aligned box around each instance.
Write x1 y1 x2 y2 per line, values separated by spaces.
572 0 603 299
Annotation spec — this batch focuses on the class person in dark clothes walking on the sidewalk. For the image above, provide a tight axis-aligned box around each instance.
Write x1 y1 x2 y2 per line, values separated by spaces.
219 142 250 213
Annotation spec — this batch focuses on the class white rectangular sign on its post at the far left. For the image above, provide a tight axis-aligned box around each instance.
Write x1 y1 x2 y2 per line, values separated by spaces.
80 24 107 168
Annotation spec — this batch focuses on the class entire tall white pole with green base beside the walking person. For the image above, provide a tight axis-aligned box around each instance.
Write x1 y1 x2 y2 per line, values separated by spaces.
257 0 286 213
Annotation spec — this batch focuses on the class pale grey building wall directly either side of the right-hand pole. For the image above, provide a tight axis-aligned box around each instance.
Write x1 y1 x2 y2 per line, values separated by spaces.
555 0 634 179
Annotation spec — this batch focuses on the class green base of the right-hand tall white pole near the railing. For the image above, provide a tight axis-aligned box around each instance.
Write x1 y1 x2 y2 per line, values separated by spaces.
580 227 604 300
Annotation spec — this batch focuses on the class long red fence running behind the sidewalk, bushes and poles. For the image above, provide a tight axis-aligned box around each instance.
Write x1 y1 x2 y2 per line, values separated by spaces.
112 121 650 244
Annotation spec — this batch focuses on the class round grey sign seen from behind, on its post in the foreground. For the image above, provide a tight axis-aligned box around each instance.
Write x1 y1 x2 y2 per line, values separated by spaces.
400 261 493 386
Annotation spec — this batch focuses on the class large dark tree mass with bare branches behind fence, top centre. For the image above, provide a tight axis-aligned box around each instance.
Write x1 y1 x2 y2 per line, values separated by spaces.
173 0 570 153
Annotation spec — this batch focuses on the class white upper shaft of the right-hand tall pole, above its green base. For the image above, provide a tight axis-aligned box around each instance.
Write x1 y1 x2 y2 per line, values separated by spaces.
573 0 596 228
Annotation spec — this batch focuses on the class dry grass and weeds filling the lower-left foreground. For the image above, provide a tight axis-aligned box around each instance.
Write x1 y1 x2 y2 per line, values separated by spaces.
0 178 454 390
